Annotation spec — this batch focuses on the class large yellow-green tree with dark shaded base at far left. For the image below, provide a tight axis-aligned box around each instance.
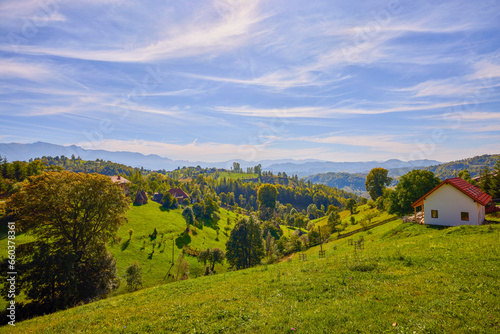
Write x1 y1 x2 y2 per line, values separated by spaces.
4 172 128 310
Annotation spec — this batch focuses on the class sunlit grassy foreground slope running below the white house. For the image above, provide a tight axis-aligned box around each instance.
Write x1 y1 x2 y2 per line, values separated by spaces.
0 218 500 333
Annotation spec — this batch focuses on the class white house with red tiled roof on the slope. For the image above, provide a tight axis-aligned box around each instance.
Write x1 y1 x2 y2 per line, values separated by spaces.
412 177 491 226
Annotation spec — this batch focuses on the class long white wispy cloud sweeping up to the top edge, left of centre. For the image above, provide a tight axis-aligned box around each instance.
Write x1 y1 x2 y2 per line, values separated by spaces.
2 1 267 62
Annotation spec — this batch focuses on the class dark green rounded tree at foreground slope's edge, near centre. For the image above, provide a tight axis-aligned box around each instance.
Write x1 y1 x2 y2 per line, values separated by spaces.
226 216 265 269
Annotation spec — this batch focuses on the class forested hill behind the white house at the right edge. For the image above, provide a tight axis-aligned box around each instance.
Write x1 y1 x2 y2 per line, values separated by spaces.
424 154 500 180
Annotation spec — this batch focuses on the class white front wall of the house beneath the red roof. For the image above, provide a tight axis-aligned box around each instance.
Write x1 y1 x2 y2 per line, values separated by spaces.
424 184 485 226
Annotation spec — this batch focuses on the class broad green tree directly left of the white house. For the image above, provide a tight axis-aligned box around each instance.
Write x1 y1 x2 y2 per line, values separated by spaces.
388 169 441 215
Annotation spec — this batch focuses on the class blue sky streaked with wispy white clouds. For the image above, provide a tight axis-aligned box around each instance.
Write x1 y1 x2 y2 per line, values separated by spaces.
0 0 500 162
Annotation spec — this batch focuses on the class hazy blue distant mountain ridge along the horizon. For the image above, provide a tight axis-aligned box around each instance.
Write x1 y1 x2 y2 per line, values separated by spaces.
0 142 440 177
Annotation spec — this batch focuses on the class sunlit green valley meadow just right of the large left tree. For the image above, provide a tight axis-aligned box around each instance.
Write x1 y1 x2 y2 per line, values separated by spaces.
108 201 240 294
